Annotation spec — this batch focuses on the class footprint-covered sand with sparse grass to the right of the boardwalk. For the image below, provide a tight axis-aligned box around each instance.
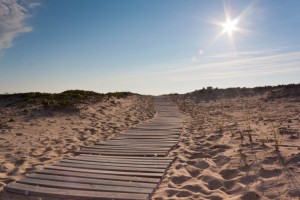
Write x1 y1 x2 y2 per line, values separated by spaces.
152 86 300 200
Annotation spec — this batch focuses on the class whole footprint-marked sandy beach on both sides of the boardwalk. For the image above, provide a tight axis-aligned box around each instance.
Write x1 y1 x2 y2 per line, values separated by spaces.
0 85 300 200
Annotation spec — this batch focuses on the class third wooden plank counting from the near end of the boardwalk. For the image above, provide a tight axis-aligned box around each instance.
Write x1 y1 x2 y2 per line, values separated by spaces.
27 174 156 188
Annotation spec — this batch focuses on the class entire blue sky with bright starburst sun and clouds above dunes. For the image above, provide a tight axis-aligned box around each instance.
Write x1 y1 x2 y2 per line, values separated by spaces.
0 0 300 95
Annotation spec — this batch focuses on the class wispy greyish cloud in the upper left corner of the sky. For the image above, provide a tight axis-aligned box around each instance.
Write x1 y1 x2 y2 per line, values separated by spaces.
0 0 40 52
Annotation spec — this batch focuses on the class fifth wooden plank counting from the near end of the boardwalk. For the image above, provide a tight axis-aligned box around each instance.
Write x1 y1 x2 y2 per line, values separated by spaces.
45 166 163 178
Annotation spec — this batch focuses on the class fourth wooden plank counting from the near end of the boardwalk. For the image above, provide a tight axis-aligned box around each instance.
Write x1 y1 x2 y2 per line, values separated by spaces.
35 169 159 183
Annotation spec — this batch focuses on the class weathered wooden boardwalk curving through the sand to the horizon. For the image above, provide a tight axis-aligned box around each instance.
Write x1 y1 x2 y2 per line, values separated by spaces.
4 97 184 199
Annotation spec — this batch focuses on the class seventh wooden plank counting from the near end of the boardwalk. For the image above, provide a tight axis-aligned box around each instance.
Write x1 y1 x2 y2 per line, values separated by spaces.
60 160 166 169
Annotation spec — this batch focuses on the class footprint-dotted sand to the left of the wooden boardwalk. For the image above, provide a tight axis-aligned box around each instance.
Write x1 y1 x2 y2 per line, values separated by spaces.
0 95 155 199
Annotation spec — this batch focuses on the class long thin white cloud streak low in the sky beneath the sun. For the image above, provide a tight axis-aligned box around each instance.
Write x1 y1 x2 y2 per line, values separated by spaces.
99 52 300 83
